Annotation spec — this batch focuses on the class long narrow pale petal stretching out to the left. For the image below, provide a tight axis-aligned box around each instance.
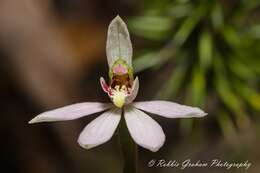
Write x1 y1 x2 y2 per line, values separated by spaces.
29 102 113 124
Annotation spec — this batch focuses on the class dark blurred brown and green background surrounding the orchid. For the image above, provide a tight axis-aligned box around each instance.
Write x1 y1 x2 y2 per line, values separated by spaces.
0 0 260 173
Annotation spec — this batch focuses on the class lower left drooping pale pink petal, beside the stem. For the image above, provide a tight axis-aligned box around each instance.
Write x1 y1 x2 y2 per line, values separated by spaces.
78 108 121 149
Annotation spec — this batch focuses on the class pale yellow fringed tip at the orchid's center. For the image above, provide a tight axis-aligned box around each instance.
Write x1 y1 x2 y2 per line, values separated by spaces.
111 85 127 108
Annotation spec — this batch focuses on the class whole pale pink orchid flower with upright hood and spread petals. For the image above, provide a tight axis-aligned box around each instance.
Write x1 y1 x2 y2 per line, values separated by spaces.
29 16 206 152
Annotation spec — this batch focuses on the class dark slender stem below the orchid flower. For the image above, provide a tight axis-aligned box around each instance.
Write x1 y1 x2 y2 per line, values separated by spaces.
119 111 138 173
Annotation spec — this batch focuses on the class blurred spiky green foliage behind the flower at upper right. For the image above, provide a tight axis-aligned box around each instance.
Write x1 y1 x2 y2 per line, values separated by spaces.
129 0 260 137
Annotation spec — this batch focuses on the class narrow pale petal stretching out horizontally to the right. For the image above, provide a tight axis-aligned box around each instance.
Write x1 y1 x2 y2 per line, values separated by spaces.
133 100 207 118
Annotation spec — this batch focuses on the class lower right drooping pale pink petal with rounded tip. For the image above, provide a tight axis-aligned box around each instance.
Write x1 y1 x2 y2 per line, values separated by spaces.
124 106 165 152
